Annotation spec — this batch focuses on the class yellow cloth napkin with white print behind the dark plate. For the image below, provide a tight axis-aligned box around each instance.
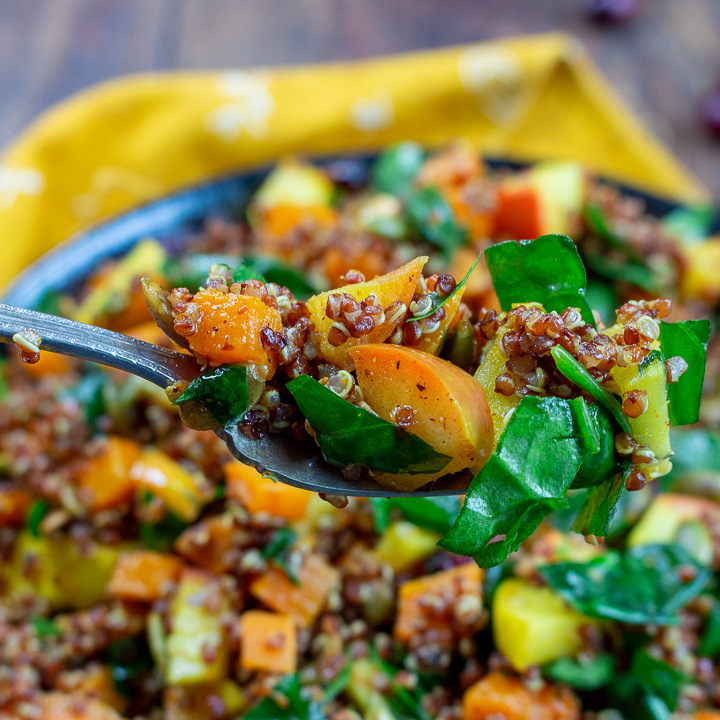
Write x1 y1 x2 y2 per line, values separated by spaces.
0 33 708 286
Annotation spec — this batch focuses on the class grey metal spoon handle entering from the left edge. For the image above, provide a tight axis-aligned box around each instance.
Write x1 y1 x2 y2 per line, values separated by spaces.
0 303 199 388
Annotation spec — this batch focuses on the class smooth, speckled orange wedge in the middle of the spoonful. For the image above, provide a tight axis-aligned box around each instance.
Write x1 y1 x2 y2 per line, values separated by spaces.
350 343 493 491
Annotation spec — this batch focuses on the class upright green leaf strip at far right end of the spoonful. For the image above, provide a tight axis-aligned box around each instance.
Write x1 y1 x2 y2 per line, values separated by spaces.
660 320 710 425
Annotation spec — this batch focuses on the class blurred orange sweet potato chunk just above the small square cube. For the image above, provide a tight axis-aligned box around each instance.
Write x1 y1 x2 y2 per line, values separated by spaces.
250 555 340 627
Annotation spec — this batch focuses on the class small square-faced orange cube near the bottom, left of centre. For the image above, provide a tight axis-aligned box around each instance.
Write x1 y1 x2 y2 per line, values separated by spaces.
240 610 297 673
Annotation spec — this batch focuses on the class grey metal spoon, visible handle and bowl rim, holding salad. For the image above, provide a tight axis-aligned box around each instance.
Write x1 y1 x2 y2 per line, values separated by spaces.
0 302 467 497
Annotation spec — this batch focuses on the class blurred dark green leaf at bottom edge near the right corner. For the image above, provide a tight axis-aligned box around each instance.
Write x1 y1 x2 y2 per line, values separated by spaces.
610 650 686 720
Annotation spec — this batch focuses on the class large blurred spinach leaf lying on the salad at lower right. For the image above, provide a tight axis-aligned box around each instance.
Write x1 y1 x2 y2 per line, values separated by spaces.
539 545 712 625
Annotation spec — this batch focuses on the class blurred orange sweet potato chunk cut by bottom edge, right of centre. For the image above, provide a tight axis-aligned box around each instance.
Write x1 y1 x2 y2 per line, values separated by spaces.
463 671 580 720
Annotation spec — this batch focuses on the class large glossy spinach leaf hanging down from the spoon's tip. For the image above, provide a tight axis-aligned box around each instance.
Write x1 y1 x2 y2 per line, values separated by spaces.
439 396 586 567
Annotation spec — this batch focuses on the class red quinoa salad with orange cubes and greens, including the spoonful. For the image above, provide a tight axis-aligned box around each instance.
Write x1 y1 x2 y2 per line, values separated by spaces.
0 142 720 720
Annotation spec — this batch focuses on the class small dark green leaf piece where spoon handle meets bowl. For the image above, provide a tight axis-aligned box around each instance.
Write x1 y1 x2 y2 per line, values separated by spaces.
173 365 249 427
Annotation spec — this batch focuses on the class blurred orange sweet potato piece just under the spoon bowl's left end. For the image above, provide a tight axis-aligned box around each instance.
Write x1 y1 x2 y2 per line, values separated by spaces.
224 461 313 520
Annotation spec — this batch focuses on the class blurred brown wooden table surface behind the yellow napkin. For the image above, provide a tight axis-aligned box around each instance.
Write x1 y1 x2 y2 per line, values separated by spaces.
0 0 720 200
